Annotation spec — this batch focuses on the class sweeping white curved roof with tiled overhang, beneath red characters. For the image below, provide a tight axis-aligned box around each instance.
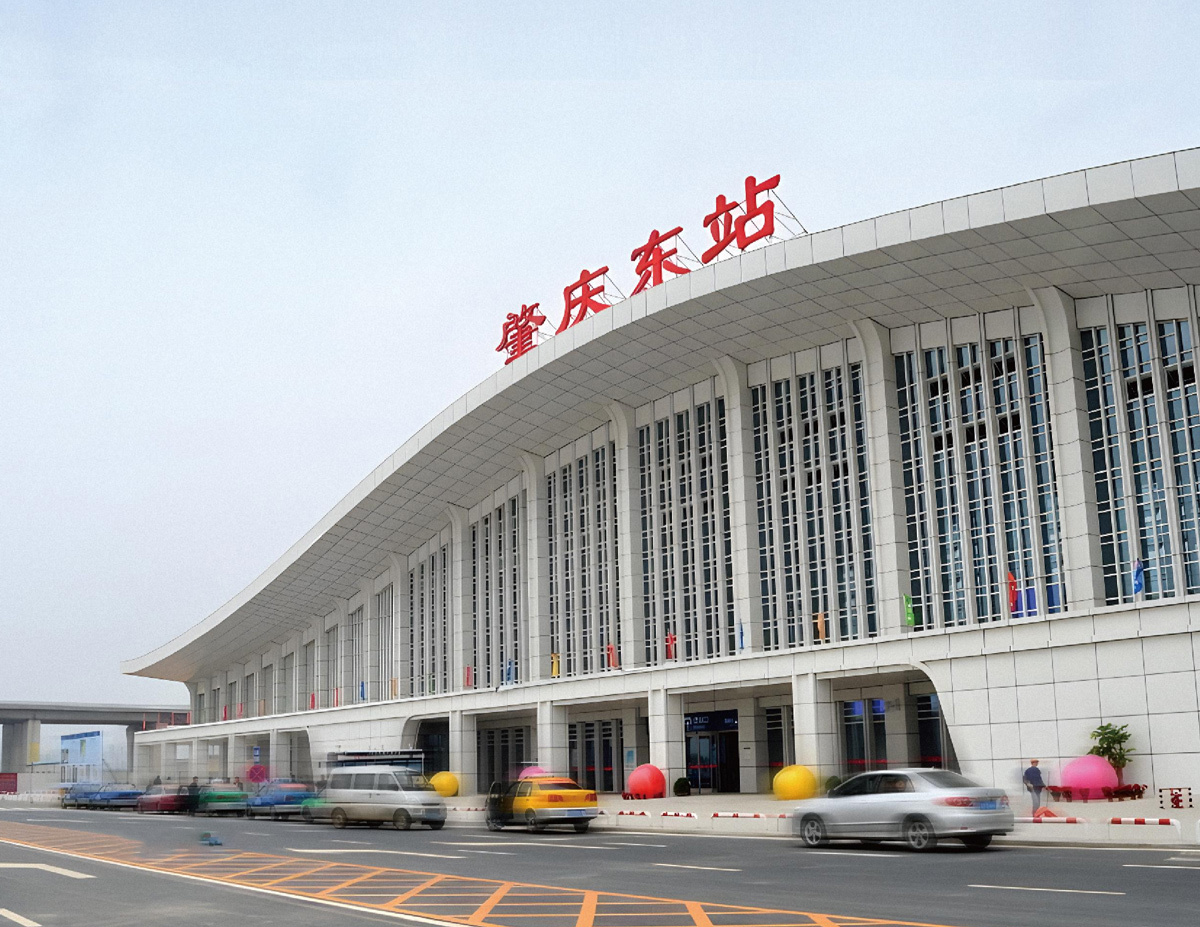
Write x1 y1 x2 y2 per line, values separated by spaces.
121 149 1200 681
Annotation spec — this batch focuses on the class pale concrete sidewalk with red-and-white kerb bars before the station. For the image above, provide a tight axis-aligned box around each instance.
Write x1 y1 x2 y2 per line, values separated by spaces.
446 794 1200 845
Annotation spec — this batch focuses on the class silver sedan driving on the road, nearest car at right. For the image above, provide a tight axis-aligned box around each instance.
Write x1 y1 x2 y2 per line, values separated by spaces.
792 770 1013 850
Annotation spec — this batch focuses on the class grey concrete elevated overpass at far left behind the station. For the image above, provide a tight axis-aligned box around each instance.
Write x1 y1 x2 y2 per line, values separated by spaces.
0 701 191 772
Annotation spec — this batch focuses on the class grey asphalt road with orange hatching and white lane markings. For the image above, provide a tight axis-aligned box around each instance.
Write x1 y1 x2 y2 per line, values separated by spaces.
0 808 1200 927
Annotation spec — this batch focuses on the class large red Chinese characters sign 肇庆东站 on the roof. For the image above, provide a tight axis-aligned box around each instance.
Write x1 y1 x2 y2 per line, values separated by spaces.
496 174 787 364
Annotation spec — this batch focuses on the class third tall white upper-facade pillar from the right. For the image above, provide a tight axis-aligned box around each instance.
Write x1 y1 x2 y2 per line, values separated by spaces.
715 357 762 653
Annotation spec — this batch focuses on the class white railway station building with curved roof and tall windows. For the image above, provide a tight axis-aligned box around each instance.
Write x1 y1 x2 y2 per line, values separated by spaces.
122 149 1200 793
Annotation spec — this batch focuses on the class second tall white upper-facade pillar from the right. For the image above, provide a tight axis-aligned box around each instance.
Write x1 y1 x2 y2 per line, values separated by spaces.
849 318 911 638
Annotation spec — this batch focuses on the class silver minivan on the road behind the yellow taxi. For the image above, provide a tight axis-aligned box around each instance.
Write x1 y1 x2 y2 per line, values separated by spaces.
305 766 446 831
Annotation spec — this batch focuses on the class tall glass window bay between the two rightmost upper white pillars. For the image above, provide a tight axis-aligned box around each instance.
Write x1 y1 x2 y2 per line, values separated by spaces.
895 334 1066 630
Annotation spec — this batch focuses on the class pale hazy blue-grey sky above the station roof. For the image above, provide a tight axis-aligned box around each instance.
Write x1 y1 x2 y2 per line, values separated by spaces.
0 0 1200 701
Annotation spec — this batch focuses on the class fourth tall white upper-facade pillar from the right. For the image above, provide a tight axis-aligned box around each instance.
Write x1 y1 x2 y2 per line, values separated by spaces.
605 402 646 667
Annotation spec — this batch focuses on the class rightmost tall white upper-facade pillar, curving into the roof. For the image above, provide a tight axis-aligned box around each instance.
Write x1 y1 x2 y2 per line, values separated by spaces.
1028 287 1104 609
